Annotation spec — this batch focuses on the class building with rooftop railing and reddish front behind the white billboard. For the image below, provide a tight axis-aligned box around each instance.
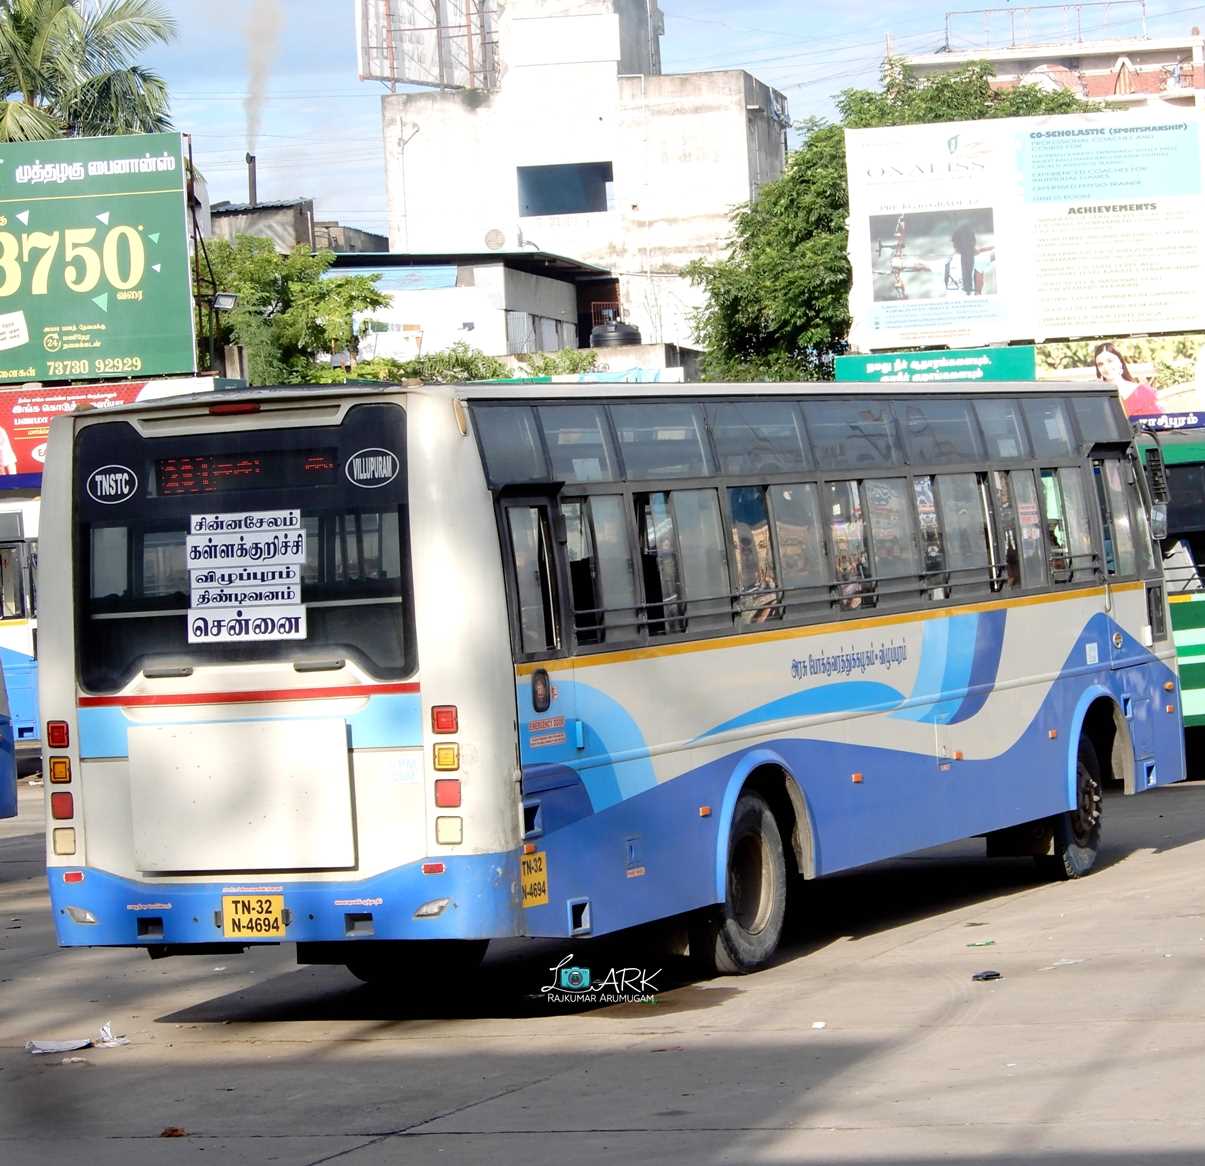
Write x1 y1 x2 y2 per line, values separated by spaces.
903 0 1205 107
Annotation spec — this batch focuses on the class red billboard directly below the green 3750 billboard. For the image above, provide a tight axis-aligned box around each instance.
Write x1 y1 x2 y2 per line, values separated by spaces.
0 377 219 481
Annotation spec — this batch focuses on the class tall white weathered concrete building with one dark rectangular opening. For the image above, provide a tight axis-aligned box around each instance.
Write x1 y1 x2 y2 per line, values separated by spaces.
377 0 788 351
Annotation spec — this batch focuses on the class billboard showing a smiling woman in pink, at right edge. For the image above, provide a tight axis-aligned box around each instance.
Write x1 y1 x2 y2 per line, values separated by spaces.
1036 332 1205 429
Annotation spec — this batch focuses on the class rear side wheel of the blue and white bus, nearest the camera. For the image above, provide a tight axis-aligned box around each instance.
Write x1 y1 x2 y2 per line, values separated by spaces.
690 791 787 976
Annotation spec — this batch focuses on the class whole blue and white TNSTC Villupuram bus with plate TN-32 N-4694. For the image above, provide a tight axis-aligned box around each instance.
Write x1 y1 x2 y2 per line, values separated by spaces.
40 383 1185 984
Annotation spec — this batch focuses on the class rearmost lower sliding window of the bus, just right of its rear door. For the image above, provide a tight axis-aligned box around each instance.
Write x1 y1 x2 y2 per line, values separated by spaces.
560 494 637 644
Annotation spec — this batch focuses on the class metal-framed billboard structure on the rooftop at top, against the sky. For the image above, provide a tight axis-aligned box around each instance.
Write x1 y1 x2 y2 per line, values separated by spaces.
355 0 498 89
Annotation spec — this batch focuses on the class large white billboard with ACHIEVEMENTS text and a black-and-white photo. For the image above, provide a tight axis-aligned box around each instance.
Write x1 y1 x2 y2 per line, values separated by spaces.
845 108 1205 352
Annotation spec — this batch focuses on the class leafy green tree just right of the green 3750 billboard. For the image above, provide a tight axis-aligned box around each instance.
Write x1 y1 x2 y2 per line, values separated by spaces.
201 235 389 384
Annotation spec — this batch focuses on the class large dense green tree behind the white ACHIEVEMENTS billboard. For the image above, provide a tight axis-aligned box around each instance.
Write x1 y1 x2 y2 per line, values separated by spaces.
687 60 1095 381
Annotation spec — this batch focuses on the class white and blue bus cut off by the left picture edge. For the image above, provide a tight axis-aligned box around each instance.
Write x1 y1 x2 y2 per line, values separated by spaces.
0 490 41 772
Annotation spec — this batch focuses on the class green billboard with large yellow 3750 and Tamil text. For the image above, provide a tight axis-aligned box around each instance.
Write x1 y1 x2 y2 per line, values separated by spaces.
0 134 196 382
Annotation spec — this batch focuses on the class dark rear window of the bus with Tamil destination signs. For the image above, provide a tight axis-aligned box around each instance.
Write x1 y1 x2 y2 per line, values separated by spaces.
76 405 416 691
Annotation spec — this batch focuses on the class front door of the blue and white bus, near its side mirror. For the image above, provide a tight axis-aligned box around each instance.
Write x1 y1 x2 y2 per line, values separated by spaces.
1092 448 1168 766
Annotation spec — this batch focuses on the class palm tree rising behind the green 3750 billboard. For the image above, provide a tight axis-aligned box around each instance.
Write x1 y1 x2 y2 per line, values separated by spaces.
0 0 176 142
